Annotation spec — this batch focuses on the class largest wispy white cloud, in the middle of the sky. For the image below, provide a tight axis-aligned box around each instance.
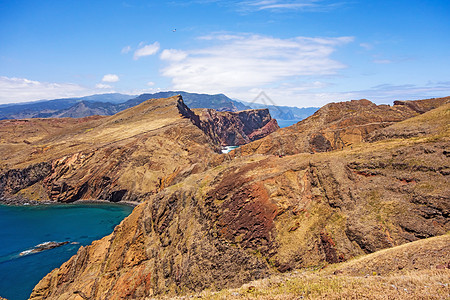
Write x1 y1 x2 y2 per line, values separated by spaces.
162 34 353 101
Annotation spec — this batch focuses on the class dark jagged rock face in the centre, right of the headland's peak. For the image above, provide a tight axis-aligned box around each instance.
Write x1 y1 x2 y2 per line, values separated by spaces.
195 109 280 146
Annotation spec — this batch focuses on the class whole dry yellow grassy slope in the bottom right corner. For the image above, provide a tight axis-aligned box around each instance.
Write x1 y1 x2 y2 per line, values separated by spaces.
180 234 450 299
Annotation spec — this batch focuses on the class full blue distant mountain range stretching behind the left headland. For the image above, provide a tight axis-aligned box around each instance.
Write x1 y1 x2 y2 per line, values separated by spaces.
0 91 318 120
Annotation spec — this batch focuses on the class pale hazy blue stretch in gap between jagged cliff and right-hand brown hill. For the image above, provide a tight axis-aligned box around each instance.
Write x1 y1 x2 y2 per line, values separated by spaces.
241 101 319 121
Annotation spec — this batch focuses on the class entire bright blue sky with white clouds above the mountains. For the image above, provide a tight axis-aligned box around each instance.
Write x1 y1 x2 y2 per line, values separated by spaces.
0 0 450 107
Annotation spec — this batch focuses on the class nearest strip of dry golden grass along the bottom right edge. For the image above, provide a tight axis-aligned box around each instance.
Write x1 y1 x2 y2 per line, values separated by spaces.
192 270 450 299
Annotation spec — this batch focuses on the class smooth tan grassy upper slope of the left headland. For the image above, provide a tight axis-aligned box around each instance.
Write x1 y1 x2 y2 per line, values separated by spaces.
0 97 186 168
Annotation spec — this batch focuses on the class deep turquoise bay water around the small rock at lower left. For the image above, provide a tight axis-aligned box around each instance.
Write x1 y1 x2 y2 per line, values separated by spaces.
0 204 133 300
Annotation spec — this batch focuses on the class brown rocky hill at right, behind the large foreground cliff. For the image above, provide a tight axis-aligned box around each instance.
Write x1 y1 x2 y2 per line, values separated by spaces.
239 97 450 155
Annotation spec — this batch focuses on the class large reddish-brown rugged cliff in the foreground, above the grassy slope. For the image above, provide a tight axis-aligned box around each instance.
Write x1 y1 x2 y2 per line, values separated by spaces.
31 105 450 299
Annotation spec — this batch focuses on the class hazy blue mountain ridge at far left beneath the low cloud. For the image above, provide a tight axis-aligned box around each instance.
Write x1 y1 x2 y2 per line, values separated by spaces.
0 93 135 120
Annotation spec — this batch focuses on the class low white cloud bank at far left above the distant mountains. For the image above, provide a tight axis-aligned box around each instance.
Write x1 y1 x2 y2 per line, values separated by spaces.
0 76 94 103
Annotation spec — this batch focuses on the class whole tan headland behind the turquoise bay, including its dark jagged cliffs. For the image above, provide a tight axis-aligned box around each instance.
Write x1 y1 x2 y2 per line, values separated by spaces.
0 96 276 202
